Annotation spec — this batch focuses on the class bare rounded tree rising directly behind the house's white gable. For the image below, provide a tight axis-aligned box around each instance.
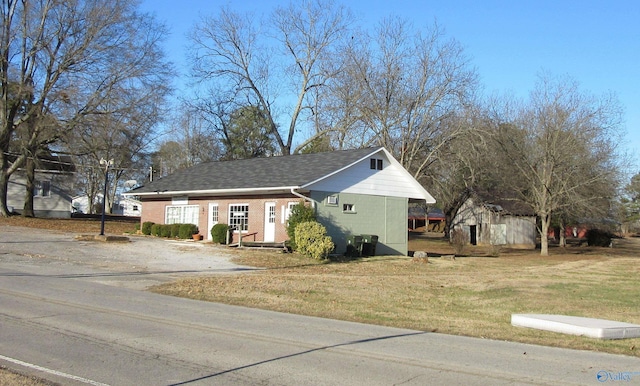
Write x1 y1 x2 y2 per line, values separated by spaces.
329 18 477 179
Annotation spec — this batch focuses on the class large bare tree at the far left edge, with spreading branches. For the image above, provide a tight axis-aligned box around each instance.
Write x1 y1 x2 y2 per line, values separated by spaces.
0 0 168 216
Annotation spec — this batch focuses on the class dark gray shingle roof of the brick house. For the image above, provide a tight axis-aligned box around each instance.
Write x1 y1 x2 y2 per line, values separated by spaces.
128 147 381 195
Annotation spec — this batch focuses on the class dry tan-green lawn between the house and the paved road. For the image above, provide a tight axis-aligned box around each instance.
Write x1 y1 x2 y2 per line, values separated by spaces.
154 232 640 356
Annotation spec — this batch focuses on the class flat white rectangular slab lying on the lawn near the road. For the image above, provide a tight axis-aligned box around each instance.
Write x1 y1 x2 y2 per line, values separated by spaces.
511 314 640 339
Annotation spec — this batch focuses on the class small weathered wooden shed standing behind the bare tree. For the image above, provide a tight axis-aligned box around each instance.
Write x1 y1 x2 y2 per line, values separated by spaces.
452 194 537 249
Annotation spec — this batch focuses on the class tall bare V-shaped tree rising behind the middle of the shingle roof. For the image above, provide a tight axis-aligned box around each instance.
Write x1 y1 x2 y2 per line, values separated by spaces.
192 0 350 155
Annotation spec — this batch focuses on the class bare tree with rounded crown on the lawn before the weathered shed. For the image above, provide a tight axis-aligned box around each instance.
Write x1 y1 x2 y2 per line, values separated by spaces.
494 75 621 256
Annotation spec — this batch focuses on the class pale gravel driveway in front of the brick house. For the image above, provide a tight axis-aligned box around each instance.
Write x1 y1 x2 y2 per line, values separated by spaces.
0 226 253 289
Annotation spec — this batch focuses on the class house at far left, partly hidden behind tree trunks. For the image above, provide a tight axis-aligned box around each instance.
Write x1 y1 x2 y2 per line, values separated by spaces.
7 156 76 218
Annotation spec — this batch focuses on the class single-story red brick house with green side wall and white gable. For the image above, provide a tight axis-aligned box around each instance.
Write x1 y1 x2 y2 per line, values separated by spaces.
125 147 435 255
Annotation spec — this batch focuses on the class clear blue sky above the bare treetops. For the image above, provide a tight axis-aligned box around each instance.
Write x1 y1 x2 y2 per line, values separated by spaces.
142 0 640 168
